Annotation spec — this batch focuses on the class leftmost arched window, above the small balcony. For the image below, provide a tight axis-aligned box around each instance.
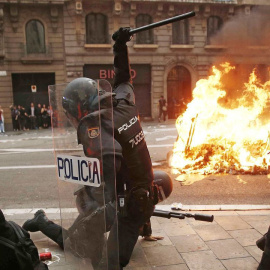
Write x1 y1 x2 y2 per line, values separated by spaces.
25 20 46 53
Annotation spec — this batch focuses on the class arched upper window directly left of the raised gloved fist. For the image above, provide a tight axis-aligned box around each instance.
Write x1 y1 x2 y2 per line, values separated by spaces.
86 13 109 44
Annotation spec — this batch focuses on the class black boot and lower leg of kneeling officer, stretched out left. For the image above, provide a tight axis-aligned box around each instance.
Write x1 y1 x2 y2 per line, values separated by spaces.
22 210 64 249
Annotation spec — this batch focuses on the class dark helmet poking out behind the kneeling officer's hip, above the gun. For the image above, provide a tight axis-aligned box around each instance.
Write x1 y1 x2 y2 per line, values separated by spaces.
154 171 173 202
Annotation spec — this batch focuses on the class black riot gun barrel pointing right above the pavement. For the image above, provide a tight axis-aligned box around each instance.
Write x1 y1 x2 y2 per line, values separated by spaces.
153 209 214 222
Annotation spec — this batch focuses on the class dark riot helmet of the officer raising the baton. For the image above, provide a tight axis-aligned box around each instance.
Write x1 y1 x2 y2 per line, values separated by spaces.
62 77 111 127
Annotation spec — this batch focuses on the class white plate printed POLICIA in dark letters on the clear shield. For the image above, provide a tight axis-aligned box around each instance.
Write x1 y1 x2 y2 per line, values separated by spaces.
57 155 101 187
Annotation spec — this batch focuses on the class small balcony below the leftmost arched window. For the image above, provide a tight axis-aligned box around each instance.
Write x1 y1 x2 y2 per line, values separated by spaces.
21 43 53 64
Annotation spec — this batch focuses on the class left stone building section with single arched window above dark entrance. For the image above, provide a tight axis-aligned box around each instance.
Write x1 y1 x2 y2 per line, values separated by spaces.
0 0 66 130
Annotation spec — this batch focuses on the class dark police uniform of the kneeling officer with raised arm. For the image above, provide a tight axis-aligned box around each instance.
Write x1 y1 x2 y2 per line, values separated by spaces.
23 29 154 270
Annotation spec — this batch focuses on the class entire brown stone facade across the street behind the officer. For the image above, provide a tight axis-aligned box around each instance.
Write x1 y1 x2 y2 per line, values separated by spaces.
0 0 270 130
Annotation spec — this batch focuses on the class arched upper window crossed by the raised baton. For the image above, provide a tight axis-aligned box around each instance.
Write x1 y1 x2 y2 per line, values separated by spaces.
136 14 154 44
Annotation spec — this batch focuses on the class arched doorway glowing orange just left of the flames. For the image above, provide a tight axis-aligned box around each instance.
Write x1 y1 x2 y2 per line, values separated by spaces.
167 66 192 119
